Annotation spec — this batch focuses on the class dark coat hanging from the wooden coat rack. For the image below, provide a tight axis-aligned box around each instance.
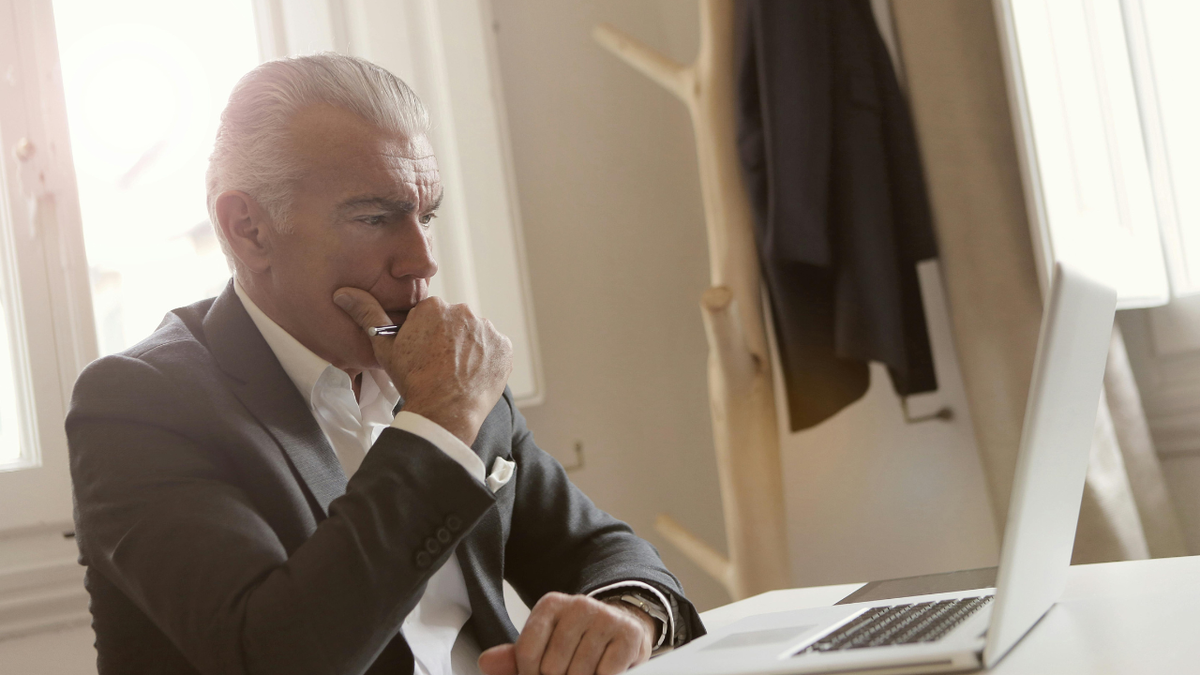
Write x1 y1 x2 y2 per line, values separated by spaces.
737 0 937 430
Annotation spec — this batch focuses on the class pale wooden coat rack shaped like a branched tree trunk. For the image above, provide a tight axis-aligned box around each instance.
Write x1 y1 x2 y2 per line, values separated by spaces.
593 0 791 599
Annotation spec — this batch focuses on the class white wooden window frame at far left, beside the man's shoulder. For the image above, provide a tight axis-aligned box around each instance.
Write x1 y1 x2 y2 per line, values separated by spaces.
0 0 97 531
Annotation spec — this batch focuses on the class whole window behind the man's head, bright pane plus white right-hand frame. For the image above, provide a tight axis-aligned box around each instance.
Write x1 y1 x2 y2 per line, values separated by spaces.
54 0 541 389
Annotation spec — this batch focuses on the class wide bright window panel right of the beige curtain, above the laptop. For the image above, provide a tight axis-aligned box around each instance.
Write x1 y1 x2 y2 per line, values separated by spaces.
996 0 1170 309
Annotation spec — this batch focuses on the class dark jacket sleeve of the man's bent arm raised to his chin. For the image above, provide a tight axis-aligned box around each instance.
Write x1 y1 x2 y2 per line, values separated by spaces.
66 357 494 675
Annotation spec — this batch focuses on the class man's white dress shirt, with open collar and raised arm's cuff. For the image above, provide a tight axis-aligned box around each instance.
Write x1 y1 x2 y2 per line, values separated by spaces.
234 281 484 675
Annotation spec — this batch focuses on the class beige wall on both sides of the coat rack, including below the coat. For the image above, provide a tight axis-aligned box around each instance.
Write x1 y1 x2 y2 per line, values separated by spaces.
493 0 997 608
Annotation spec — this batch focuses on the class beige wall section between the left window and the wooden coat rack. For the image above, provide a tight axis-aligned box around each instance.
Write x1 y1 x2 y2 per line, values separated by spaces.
493 0 726 607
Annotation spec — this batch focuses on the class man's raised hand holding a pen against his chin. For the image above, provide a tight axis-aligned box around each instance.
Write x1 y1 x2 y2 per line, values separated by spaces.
334 288 512 446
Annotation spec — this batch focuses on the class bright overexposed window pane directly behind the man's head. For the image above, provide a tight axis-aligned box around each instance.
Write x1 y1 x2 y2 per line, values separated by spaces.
54 0 258 354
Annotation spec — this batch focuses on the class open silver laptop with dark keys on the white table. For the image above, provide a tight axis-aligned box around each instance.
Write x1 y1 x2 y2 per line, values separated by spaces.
631 258 1116 675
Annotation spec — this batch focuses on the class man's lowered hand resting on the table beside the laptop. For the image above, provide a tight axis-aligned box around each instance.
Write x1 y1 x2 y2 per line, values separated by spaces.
479 593 658 675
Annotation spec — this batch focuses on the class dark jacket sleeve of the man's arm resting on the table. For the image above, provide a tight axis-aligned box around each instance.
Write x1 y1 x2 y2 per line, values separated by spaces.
504 392 704 646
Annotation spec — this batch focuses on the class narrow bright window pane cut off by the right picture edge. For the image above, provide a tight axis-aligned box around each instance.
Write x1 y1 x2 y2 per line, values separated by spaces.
1141 0 1200 285
